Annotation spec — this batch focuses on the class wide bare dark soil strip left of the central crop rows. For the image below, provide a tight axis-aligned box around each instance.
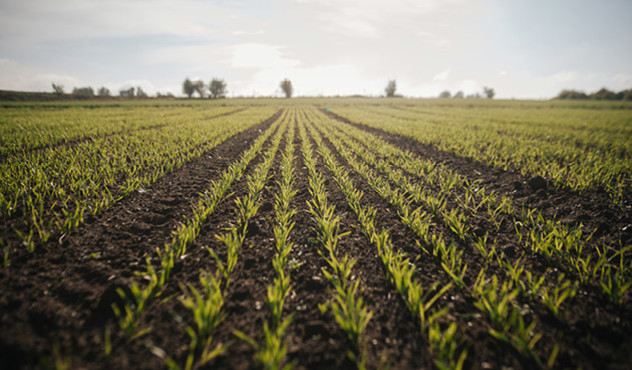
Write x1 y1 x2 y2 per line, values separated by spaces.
0 111 281 367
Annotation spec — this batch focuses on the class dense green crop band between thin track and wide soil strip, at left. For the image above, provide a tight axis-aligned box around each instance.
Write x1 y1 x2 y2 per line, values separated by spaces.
0 107 274 258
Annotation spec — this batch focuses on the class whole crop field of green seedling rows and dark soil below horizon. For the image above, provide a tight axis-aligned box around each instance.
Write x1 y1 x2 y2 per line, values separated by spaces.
0 99 632 369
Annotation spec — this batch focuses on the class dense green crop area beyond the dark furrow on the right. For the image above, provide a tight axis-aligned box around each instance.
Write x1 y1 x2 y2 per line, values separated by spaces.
333 101 632 206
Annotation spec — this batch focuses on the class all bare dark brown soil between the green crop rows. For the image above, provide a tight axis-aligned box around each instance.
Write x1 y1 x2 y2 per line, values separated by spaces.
0 107 632 369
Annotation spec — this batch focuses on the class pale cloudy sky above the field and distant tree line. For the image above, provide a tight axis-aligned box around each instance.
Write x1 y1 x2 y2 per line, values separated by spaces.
0 0 632 99
